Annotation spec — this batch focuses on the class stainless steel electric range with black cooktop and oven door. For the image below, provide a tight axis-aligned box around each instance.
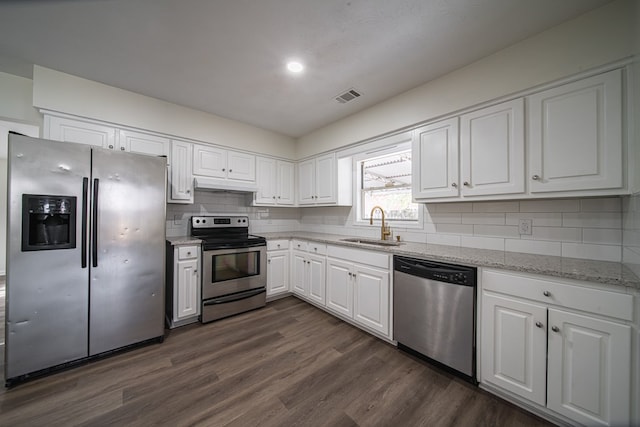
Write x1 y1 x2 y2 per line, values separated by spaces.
189 216 267 323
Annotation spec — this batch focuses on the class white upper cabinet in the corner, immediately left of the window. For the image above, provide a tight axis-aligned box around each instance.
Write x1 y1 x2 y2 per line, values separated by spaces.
298 153 353 206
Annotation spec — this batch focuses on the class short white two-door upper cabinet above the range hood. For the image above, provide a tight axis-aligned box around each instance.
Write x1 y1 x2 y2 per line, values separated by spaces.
193 144 256 182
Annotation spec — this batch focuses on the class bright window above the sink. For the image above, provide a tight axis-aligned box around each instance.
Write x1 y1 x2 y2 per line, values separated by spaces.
356 144 420 226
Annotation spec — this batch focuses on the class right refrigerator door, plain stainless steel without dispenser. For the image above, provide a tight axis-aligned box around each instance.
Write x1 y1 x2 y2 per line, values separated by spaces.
89 149 167 356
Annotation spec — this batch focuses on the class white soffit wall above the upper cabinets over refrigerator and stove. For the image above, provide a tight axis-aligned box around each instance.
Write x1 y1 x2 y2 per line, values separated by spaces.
33 66 295 159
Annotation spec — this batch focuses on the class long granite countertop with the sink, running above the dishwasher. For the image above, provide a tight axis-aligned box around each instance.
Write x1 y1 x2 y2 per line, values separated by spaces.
259 231 640 291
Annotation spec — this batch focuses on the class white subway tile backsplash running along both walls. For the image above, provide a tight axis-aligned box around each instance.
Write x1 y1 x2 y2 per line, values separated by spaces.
167 191 640 264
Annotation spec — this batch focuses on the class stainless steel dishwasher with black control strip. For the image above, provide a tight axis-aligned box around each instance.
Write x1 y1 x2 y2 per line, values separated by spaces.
393 256 477 383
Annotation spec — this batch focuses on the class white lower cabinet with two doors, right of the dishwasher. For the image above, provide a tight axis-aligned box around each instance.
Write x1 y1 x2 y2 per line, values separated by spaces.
480 270 638 426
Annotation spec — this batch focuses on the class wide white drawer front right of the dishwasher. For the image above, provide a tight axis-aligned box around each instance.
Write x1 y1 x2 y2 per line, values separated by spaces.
482 270 633 321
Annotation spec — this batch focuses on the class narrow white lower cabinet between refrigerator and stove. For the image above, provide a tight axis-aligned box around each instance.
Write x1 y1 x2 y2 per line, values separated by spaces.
166 244 200 328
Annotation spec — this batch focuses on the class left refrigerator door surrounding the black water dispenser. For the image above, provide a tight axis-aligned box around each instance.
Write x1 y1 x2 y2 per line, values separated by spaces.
5 135 91 380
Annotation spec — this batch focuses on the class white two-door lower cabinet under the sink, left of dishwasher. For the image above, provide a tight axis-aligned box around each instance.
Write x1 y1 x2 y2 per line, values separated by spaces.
327 246 391 338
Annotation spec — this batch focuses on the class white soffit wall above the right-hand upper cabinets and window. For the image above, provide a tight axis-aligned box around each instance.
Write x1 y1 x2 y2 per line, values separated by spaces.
296 0 636 159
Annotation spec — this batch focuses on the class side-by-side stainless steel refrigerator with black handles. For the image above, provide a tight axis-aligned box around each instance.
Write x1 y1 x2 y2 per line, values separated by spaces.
5 135 167 386
